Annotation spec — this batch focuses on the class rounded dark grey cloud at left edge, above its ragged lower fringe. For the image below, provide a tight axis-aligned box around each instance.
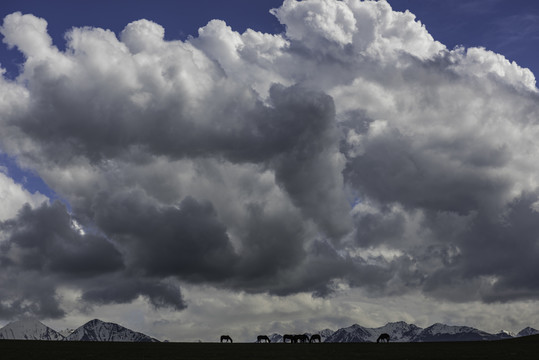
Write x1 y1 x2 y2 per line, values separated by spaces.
0 202 123 277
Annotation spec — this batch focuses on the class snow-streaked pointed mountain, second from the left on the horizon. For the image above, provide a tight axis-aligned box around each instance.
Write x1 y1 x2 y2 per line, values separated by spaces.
66 319 158 342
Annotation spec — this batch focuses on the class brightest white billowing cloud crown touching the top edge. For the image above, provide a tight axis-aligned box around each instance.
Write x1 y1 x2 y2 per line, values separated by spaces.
273 0 445 62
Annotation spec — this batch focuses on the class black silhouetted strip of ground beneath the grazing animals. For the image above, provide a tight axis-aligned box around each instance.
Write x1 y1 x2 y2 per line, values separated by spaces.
0 335 539 360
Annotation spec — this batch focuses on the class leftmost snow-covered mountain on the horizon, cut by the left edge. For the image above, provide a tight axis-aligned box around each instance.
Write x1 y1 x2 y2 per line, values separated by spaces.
0 319 64 340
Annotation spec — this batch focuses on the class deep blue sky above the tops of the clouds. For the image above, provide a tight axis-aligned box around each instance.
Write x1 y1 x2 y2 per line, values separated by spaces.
0 0 539 78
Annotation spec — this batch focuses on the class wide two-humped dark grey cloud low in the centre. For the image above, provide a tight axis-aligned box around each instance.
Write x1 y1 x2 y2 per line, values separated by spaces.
87 175 344 300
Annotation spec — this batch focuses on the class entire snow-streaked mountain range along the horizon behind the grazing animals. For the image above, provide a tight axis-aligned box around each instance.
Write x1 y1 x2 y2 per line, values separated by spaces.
0 319 539 343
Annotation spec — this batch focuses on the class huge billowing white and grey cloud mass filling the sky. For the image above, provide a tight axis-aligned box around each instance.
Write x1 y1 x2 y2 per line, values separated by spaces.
0 0 539 324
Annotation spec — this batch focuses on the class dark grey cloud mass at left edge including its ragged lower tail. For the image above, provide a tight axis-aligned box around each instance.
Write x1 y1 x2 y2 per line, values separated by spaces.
0 202 190 318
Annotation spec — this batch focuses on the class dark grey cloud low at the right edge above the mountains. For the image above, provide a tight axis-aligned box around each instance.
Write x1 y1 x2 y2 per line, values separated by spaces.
459 193 539 302
